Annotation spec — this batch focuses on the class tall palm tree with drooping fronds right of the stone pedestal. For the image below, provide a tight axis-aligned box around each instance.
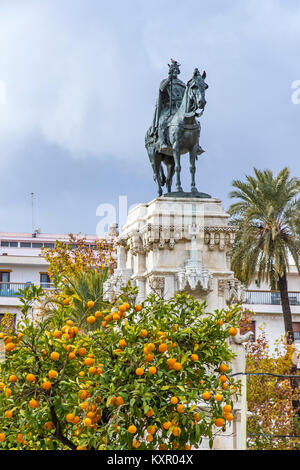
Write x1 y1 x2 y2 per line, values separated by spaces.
229 168 300 344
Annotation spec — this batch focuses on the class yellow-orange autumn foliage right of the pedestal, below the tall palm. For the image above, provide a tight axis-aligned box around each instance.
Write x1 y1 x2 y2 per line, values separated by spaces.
246 332 300 450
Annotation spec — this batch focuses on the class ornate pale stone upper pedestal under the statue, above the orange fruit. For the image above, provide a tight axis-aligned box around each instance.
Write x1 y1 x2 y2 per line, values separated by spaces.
106 197 242 311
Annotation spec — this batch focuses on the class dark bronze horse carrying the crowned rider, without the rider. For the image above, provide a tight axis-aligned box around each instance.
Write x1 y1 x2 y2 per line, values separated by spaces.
145 69 208 196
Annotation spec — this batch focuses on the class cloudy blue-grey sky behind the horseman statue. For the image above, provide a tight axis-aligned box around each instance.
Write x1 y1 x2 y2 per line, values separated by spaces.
0 0 300 234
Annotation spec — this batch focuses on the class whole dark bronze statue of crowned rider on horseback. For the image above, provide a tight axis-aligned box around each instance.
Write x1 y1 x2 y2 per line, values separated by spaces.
145 60 210 197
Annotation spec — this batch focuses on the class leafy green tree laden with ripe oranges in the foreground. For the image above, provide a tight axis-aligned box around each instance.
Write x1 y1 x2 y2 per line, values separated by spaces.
0 280 241 450
